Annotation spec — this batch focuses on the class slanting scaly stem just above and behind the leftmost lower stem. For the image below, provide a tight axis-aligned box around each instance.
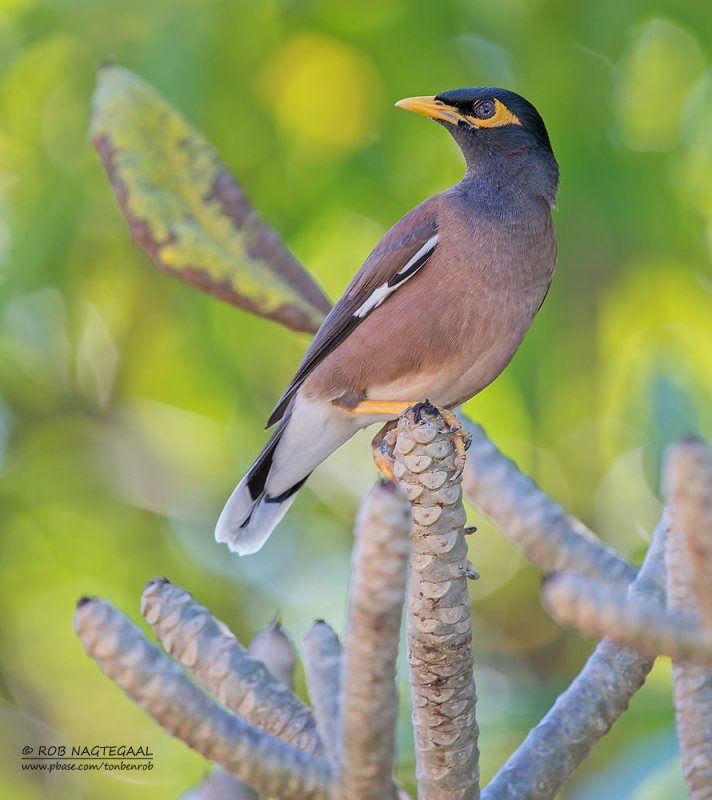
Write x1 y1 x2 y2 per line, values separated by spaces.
141 580 323 755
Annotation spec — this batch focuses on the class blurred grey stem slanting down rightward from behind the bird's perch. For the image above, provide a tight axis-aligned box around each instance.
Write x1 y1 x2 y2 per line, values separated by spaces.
458 414 636 585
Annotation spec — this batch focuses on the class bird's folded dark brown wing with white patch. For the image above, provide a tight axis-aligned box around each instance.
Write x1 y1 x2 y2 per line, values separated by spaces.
267 197 438 428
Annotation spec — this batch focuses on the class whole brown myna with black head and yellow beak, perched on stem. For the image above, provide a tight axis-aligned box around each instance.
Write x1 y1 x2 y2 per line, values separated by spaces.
215 87 559 555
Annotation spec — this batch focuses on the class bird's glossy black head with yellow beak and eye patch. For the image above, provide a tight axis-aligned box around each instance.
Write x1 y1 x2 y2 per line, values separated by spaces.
396 86 558 204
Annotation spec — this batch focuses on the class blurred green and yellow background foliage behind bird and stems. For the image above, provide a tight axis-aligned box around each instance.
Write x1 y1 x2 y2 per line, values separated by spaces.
0 0 712 800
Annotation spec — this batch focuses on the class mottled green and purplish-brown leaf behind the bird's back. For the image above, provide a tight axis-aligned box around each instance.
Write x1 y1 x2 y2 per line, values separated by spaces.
91 66 330 332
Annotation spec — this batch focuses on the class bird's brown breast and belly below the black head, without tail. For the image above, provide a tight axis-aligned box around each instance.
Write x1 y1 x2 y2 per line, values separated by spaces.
301 184 556 408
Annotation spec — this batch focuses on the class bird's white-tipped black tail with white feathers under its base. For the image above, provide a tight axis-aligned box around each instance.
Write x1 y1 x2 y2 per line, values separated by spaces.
215 398 360 555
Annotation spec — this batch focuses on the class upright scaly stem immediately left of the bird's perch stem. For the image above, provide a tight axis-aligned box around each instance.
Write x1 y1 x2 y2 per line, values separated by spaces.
340 483 410 800
